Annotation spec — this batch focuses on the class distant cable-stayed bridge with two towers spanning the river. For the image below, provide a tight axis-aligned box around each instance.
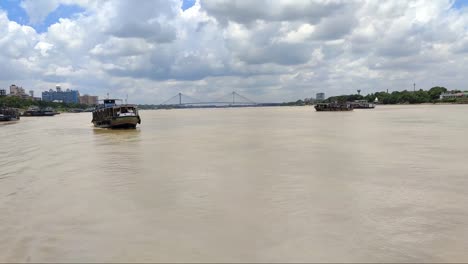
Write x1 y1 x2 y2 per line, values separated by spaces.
160 92 257 107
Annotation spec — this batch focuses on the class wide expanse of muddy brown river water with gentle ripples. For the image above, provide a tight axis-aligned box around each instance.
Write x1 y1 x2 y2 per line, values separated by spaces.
0 105 468 262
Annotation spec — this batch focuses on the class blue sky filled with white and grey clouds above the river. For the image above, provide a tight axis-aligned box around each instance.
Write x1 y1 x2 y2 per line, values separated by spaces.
0 0 468 103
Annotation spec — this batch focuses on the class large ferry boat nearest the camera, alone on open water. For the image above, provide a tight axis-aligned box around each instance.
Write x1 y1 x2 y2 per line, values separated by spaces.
91 99 141 128
